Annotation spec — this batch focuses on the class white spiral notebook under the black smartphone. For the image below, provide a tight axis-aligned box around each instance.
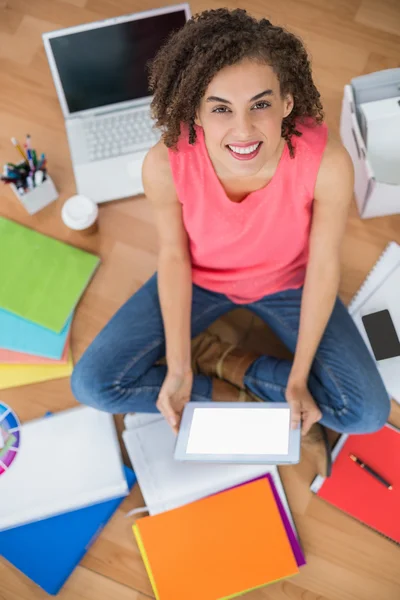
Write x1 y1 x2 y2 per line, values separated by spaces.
348 242 400 402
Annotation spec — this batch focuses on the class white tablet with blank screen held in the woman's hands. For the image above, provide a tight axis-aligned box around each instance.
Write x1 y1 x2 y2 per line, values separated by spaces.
174 402 301 465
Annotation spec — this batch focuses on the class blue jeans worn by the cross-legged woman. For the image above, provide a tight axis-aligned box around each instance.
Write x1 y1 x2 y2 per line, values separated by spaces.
71 275 390 433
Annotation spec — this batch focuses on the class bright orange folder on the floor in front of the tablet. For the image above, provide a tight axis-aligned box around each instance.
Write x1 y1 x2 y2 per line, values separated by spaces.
133 478 298 600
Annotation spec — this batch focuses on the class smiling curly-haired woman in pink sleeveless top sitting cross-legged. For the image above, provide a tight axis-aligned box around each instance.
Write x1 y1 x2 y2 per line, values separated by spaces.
72 9 390 458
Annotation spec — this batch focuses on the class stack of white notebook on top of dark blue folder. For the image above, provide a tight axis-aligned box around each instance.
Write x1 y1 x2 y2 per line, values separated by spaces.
0 407 136 594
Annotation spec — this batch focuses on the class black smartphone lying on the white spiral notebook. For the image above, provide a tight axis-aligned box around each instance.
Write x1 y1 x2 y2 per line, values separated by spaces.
361 309 400 360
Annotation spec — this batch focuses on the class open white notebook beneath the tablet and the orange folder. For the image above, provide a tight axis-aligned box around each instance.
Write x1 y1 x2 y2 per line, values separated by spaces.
122 413 296 531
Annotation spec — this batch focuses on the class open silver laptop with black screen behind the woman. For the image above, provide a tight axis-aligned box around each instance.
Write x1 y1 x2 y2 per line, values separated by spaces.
43 3 191 203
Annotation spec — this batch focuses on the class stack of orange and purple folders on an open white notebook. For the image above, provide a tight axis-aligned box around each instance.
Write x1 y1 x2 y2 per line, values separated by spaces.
123 414 305 600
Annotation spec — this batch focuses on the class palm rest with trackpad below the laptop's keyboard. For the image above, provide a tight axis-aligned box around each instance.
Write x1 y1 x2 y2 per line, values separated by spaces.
75 150 148 202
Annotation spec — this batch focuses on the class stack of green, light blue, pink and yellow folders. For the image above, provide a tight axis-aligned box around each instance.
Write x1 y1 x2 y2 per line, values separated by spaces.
0 217 100 389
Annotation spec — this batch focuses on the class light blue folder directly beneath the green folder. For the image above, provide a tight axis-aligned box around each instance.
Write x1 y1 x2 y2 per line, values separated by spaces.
0 308 72 360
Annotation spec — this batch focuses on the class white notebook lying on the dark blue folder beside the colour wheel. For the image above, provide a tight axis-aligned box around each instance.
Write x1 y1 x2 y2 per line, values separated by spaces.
0 407 128 531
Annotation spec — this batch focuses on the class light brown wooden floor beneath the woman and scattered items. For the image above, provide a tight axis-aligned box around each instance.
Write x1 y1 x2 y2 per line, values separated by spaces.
0 0 400 600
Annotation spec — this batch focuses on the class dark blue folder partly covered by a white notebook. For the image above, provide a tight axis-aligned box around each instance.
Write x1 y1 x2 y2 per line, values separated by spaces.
0 467 136 594
